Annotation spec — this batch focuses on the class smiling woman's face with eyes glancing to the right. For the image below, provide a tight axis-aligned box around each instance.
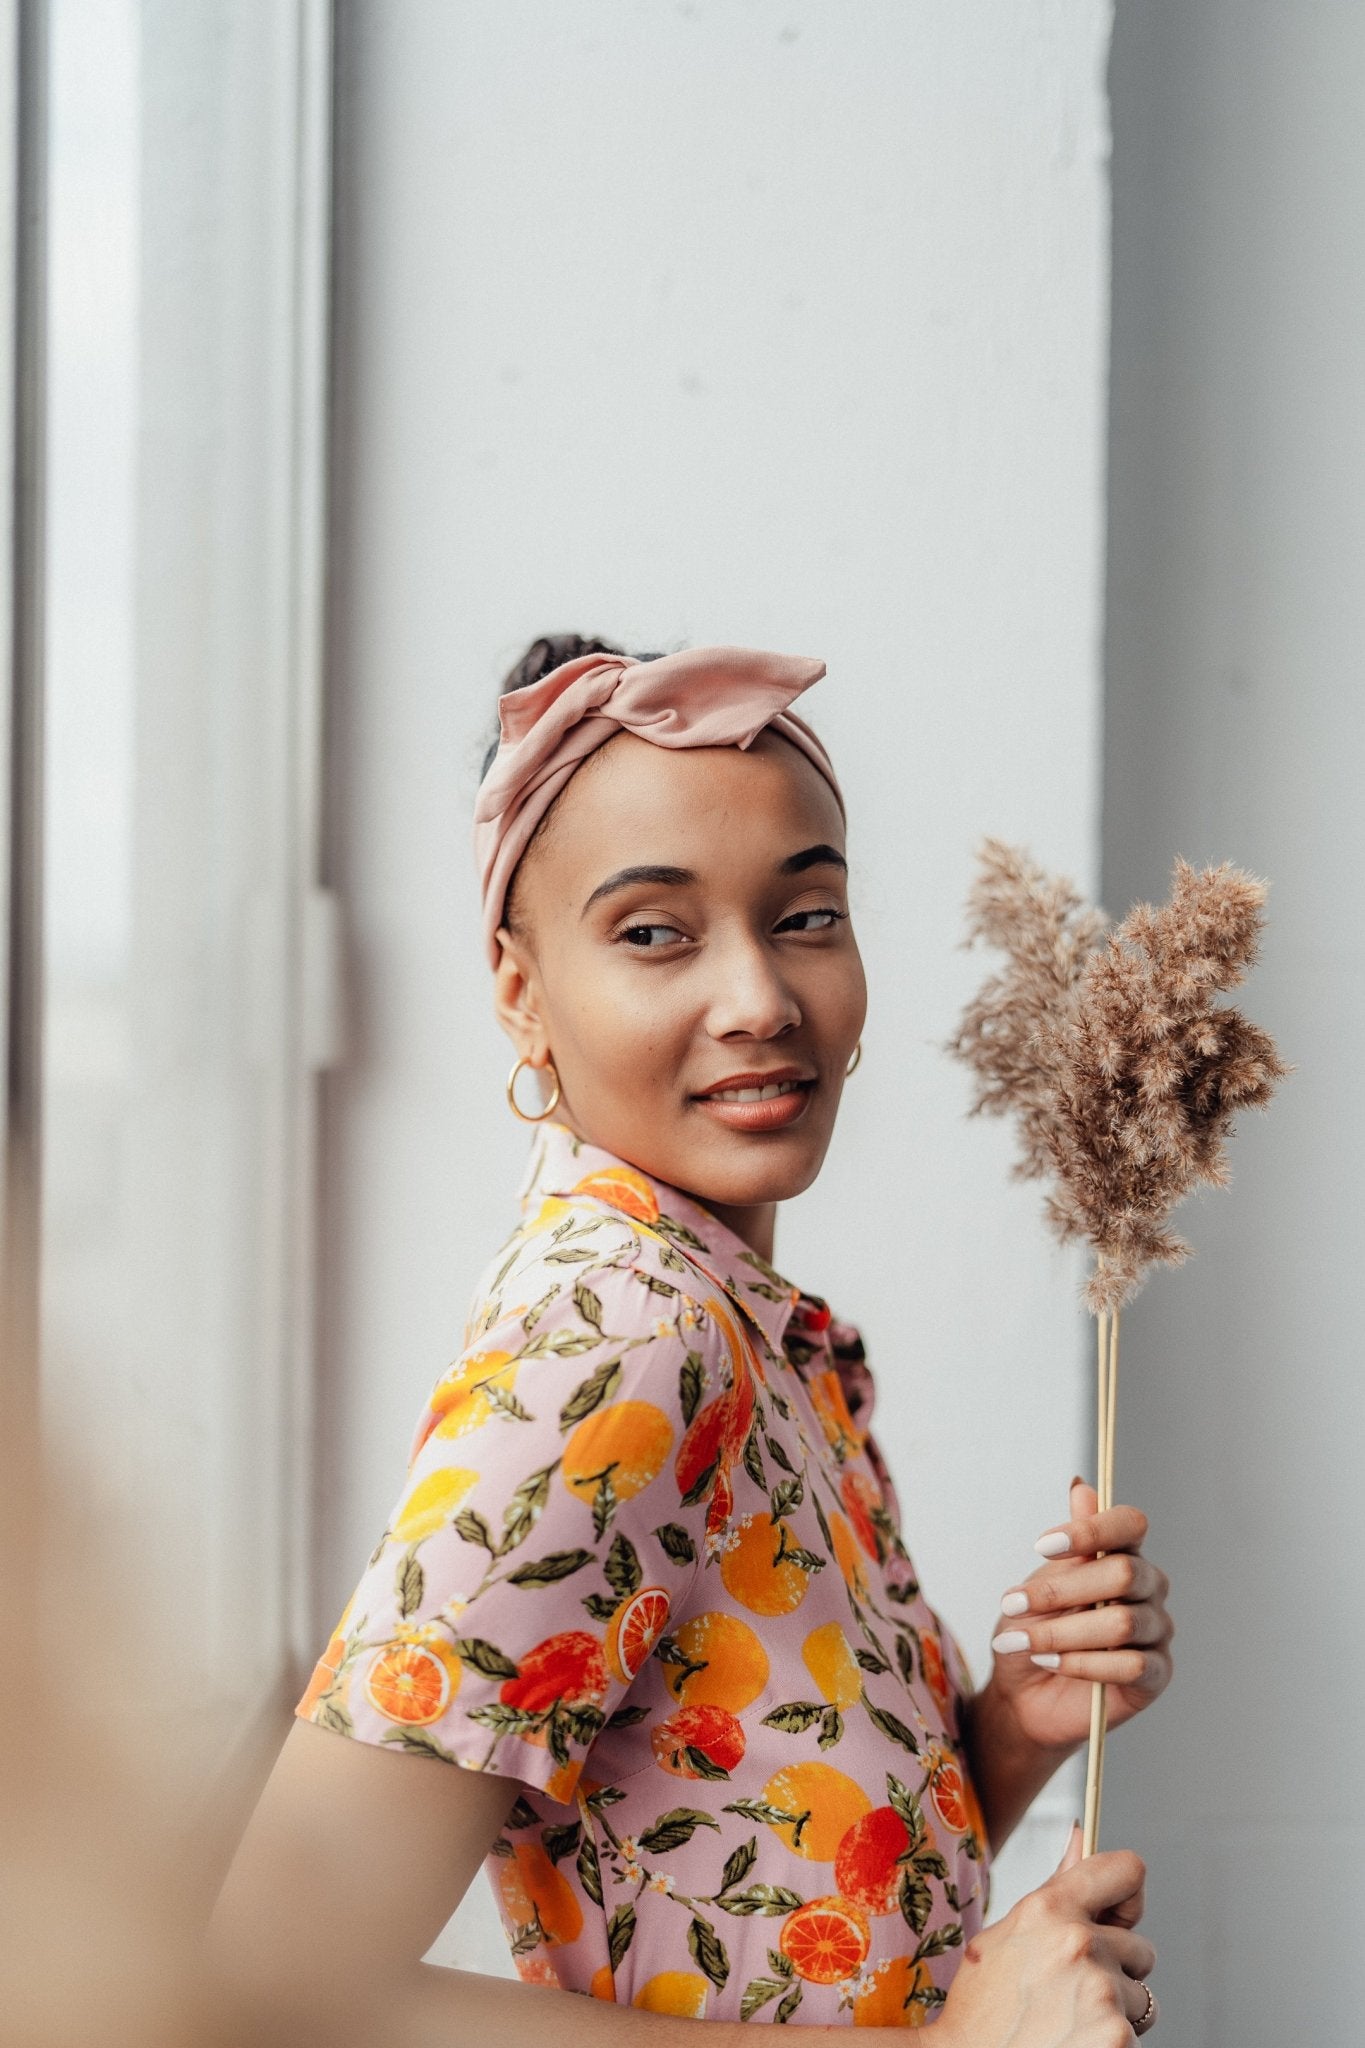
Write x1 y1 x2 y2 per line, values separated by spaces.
495 729 868 1208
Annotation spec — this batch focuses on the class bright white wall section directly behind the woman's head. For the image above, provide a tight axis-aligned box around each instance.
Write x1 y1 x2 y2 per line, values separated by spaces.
317 0 1117 1966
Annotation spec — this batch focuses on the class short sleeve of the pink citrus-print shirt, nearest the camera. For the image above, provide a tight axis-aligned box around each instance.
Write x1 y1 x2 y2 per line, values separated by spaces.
295 1264 731 1802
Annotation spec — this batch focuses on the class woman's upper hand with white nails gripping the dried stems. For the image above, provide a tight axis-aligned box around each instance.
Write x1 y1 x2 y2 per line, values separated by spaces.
988 1479 1175 1749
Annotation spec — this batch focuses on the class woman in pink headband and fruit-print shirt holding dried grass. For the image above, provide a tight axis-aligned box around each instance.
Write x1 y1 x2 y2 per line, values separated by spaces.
205 641 1173 2048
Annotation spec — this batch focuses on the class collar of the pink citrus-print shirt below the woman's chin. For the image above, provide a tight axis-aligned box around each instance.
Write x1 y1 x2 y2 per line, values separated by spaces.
518 1116 831 1358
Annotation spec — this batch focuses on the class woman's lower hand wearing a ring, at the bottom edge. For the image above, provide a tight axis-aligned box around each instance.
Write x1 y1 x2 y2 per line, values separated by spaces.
937 1825 1158 2048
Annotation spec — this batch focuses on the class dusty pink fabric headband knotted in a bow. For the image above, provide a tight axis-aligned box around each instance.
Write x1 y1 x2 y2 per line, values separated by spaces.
475 647 843 967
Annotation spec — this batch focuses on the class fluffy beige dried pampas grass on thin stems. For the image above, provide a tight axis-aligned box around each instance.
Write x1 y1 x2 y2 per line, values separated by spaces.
948 840 1293 1855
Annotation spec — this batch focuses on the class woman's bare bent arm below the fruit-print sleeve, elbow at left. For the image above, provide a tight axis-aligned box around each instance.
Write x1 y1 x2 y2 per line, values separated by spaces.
205 1720 855 2048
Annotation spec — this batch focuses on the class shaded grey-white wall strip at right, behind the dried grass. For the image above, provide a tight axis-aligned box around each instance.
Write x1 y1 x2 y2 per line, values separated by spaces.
1105 0 1365 2048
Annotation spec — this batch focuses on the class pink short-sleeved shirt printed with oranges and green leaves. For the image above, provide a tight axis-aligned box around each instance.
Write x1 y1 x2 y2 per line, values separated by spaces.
295 1120 990 2028
